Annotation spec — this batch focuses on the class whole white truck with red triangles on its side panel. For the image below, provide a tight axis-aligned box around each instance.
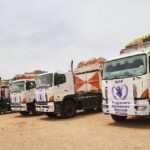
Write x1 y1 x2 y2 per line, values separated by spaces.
36 58 105 118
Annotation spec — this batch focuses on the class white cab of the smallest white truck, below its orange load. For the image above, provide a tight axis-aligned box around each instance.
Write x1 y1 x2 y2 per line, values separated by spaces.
10 79 37 115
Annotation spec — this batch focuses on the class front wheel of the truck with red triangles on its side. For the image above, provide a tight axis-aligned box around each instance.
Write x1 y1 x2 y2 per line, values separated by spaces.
61 101 76 118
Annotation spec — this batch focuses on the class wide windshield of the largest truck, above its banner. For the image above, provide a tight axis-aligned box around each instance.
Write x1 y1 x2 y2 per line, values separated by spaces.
103 54 147 80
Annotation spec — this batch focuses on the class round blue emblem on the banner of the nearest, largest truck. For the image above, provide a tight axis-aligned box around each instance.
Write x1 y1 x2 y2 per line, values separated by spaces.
112 80 128 100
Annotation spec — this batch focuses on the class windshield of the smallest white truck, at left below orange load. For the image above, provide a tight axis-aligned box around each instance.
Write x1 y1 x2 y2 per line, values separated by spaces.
10 81 25 93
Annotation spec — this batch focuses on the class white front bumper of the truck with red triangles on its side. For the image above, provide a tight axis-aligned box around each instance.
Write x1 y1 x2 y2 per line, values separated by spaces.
36 102 55 112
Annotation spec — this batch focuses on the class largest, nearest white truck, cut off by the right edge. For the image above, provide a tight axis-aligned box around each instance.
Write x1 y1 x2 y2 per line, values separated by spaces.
102 35 150 122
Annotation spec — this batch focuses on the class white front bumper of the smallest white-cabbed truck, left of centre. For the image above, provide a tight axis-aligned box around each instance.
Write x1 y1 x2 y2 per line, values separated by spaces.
11 103 27 112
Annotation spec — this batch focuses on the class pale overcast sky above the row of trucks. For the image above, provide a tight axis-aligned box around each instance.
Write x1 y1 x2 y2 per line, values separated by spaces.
0 0 150 79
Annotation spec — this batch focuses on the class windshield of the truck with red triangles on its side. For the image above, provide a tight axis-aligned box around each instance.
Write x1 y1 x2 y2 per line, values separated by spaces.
36 73 53 87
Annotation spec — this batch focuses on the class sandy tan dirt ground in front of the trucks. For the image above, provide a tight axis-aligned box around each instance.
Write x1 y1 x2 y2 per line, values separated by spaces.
0 112 150 150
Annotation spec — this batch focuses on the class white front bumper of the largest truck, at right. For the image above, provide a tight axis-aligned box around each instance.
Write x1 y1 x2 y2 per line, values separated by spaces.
102 99 150 116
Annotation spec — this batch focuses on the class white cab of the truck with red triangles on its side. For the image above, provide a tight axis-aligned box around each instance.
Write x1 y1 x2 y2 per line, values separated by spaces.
36 72 75 117
